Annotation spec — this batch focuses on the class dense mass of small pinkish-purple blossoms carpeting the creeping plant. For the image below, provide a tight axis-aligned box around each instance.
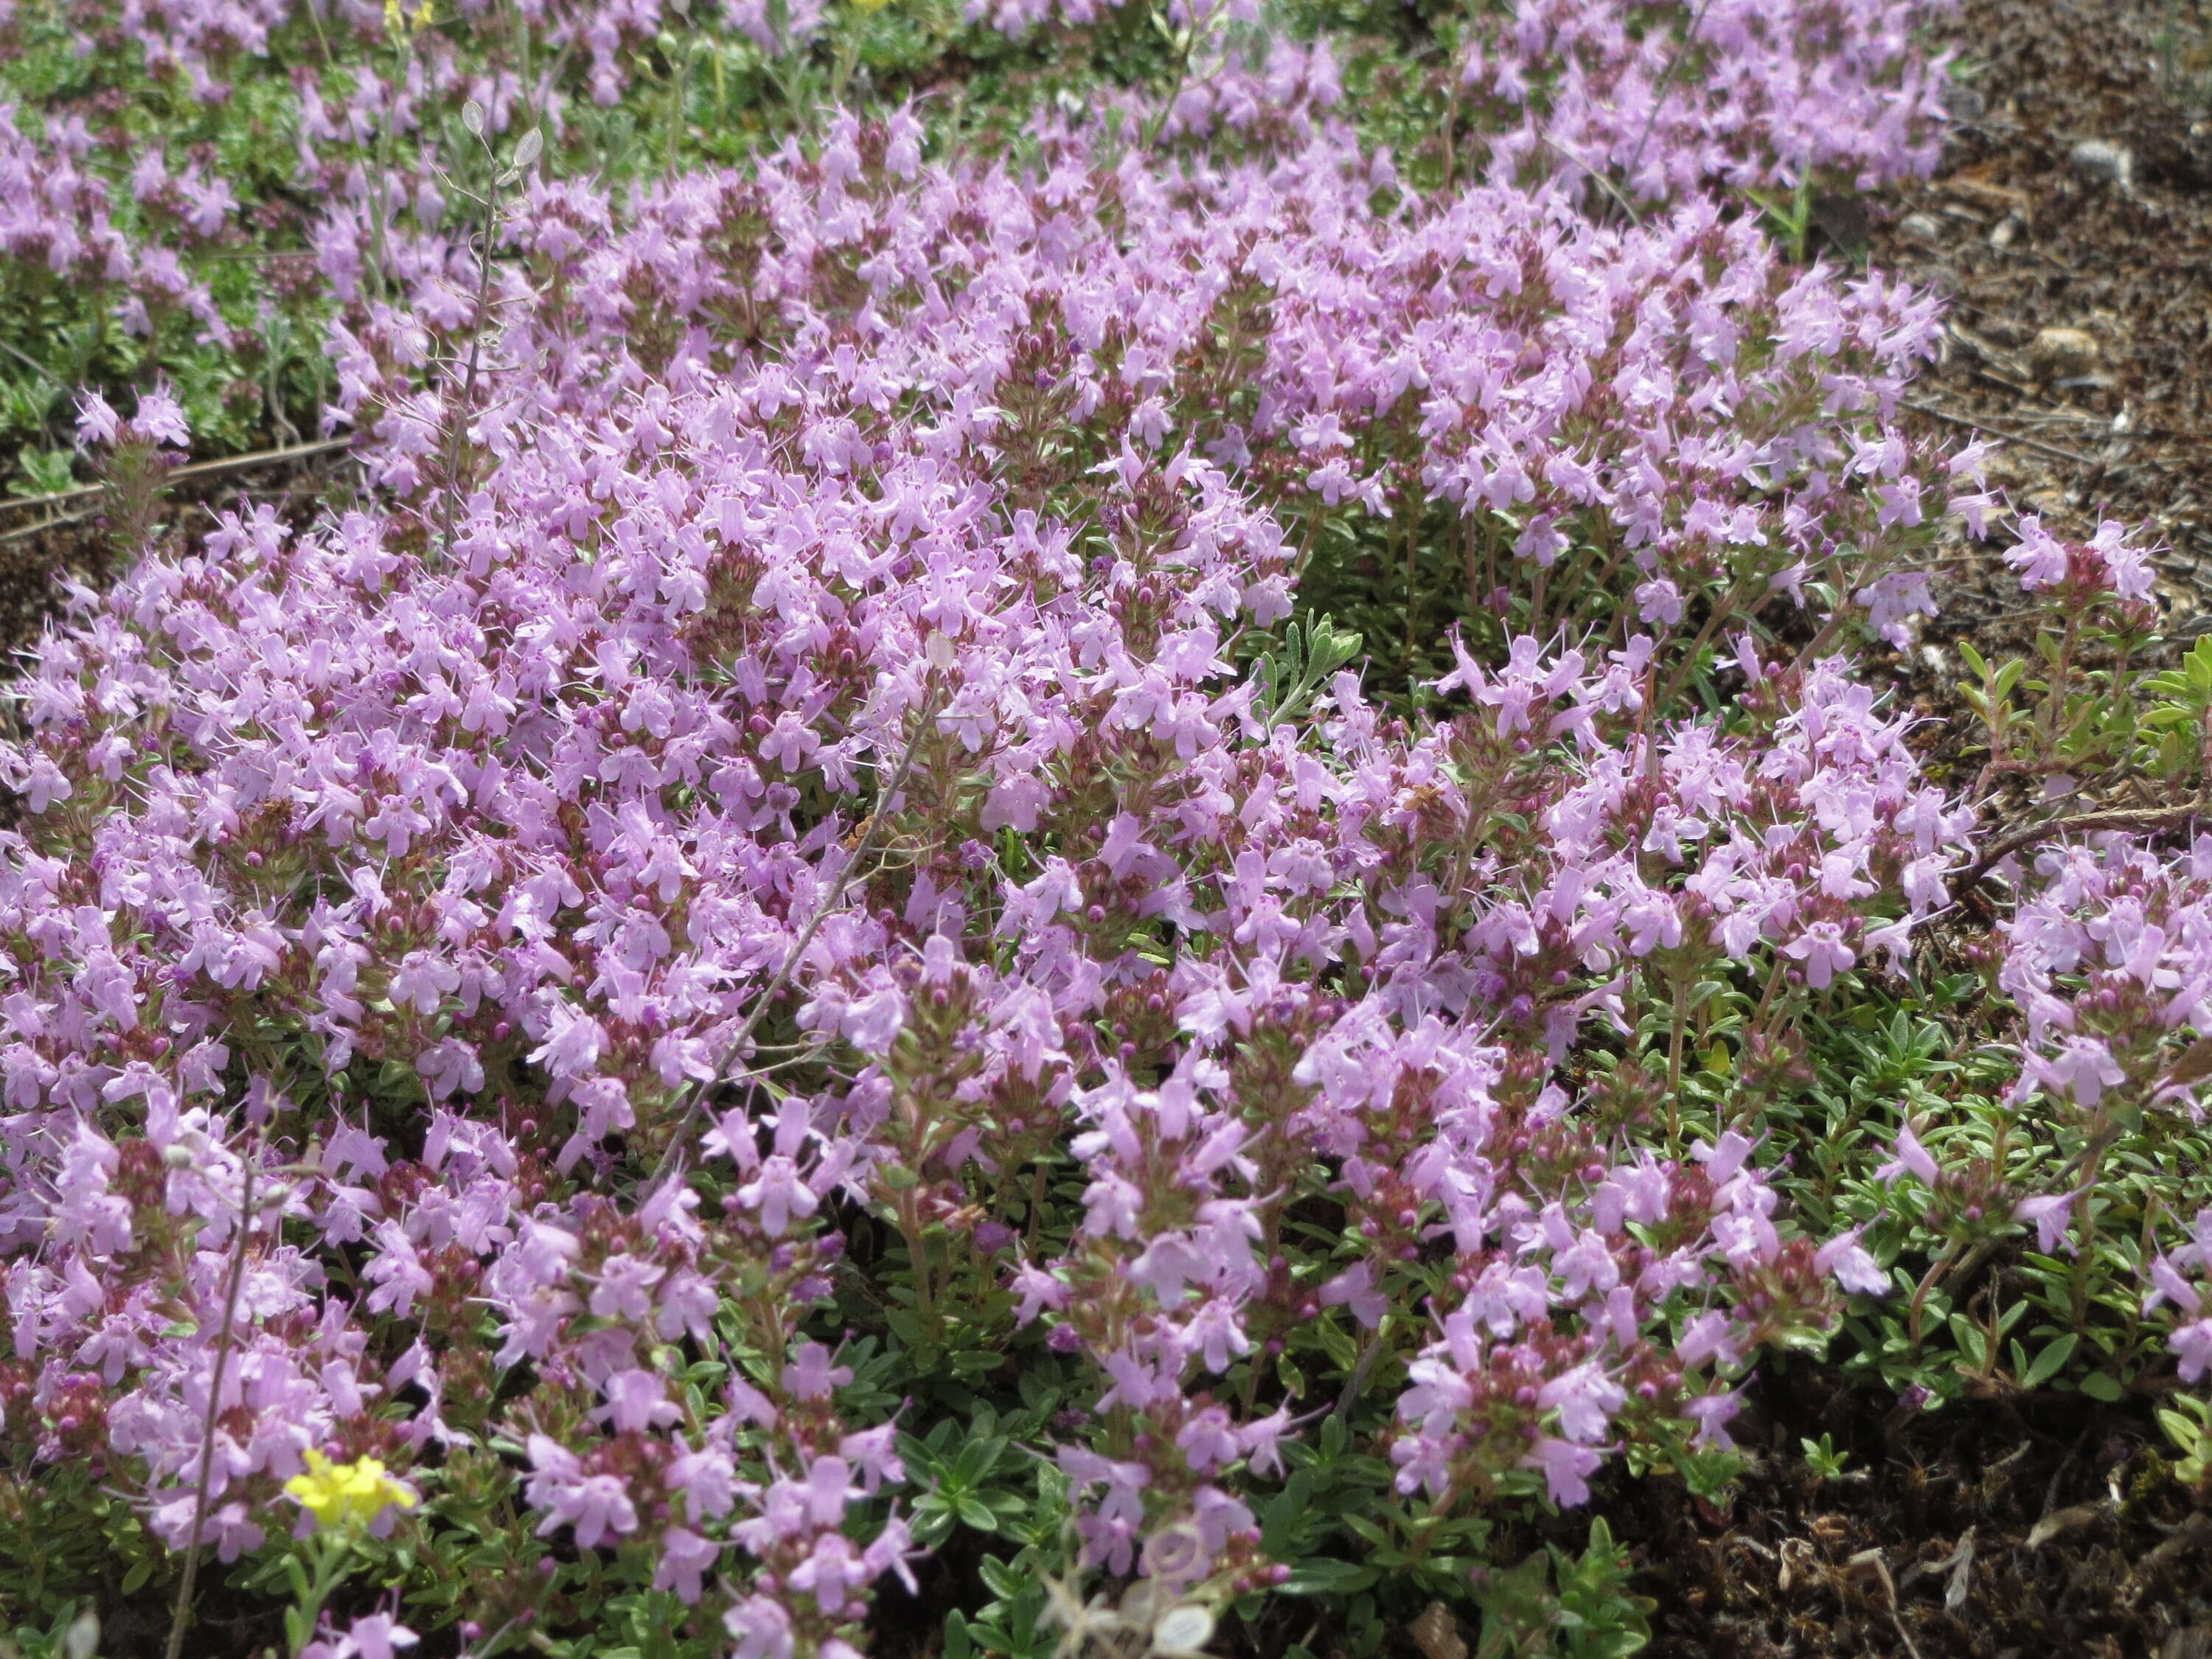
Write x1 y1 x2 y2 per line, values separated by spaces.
17 0 2212 1659
